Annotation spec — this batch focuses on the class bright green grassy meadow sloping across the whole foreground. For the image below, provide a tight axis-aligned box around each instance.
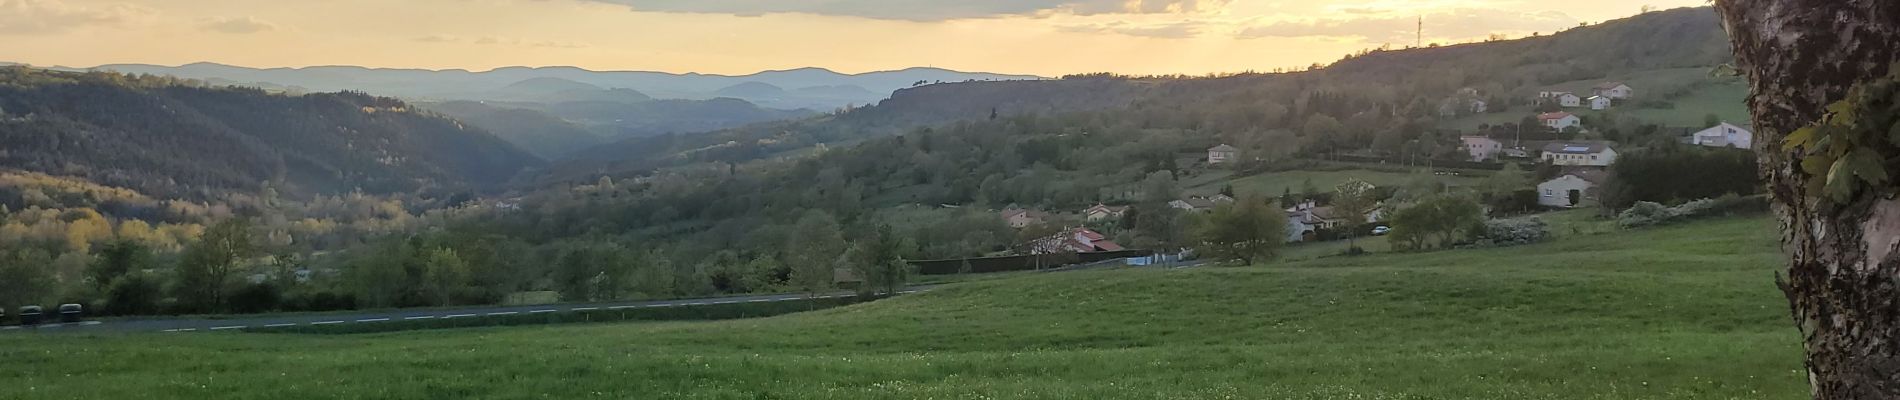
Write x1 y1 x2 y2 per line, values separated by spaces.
0 218 1807 400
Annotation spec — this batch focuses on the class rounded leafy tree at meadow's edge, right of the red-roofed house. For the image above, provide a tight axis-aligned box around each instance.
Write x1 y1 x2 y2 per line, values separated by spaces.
1193 197 1286 264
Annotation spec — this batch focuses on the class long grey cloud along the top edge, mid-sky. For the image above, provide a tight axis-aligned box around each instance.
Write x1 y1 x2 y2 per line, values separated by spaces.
589 0 1233 21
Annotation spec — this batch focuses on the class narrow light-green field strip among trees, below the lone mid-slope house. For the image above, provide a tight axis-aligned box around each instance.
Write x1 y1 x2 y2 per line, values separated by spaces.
1184 169 1480 197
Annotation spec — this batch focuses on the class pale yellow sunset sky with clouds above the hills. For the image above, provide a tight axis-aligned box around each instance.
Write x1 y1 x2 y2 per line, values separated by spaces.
0 0 1706 76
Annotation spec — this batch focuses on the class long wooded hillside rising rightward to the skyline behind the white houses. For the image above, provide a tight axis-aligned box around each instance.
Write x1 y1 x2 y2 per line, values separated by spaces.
534 8 1739 184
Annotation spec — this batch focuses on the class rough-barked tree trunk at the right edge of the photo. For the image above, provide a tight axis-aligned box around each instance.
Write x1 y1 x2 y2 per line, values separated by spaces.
1716 0 1900 398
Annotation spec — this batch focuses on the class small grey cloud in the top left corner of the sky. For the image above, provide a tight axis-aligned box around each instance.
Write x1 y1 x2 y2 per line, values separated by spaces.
0 0 154 34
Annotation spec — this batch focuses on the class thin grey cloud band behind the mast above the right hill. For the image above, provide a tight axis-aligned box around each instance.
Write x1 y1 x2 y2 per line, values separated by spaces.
1237 8 1577 42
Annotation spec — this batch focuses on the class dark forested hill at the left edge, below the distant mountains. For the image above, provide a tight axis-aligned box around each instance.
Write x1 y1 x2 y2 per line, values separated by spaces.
0 66 542 199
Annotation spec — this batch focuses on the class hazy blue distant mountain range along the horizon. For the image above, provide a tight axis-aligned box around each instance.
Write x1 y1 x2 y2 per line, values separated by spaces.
53 63 1043 110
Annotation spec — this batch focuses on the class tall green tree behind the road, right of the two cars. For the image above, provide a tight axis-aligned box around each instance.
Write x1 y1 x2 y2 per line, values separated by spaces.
177 218 258 311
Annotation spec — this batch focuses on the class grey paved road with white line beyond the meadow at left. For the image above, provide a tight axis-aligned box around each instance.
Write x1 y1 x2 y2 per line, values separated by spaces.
0 286 935 334
